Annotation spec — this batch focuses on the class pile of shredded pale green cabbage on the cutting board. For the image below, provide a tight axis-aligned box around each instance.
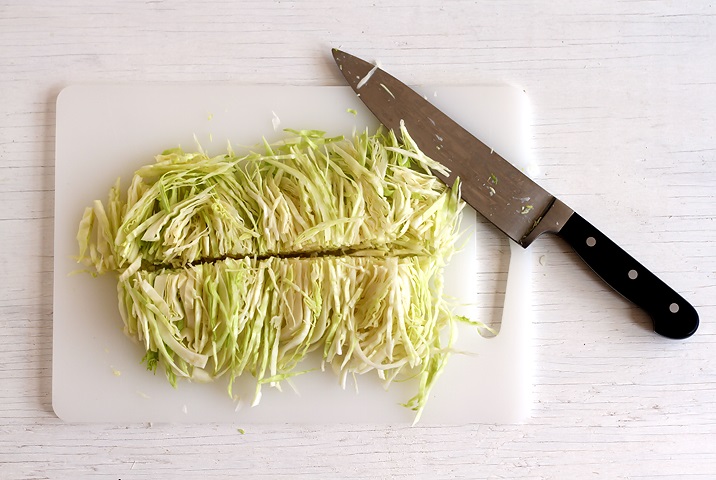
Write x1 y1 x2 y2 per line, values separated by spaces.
77 127 472 421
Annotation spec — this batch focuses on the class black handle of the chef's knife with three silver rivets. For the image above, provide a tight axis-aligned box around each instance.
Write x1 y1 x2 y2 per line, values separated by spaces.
558 212 699 339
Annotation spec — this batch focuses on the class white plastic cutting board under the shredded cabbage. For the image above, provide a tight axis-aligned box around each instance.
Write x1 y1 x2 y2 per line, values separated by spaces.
52 84 531 425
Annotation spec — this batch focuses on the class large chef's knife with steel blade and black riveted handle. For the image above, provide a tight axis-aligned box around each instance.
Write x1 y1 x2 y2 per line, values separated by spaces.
333 49 699 339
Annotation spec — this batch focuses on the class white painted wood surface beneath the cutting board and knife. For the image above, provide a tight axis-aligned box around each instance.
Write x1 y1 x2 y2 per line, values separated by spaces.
0 0 716 480
